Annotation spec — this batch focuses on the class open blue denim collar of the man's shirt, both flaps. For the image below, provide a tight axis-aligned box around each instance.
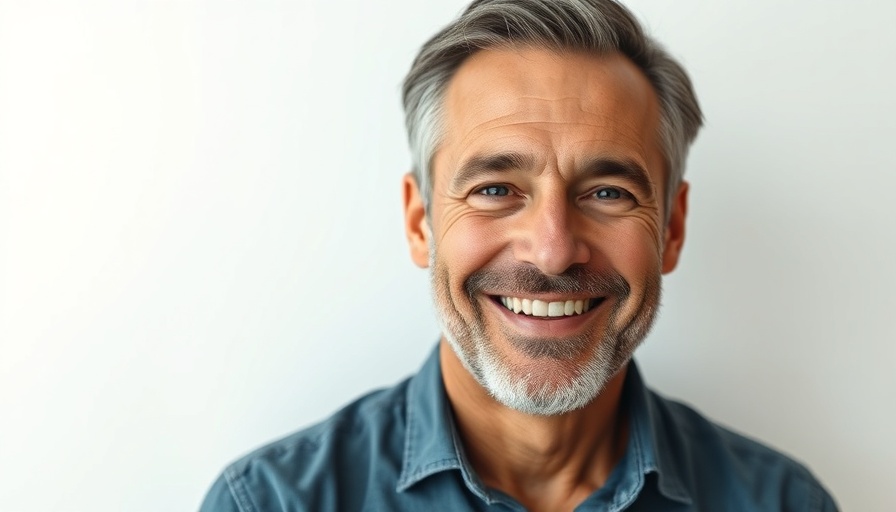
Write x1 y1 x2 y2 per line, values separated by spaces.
396 345 691 503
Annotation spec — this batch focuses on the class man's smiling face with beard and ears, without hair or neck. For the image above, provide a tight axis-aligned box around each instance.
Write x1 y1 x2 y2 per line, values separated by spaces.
405 49 687 414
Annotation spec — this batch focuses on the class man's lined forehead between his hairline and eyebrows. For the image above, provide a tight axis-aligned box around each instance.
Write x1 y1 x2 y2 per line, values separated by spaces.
435 48 662 182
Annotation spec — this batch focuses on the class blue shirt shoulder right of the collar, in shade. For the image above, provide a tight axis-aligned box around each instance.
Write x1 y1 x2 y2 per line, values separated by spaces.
650 391 836 511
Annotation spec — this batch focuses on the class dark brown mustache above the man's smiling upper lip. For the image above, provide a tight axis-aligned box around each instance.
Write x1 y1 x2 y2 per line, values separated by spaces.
464 265 631 299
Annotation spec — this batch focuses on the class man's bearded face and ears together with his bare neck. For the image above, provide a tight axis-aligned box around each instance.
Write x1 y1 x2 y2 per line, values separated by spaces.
404 47 687 511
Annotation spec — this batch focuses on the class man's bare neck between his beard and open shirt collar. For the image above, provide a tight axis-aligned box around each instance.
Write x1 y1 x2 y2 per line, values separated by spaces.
439 339 628 511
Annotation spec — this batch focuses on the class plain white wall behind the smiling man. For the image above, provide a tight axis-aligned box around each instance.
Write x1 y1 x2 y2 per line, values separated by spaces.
0 0 896 512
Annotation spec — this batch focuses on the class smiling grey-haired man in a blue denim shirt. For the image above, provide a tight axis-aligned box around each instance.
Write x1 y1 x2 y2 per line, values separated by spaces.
203 0 836 512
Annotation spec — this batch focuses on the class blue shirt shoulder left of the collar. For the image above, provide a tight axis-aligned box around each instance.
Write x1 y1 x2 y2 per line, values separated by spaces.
203 381 407 512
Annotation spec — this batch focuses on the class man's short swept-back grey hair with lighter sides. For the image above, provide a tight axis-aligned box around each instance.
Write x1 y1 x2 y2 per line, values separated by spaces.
402 0 703 218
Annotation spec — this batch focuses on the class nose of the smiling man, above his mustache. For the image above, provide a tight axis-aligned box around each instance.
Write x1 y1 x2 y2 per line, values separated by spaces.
514 194 591 275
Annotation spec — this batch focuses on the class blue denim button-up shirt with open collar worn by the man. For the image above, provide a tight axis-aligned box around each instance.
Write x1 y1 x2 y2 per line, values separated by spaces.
201 350 837 512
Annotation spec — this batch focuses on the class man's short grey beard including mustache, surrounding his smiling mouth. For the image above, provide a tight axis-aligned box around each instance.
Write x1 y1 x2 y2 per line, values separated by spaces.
429 253 661 416
